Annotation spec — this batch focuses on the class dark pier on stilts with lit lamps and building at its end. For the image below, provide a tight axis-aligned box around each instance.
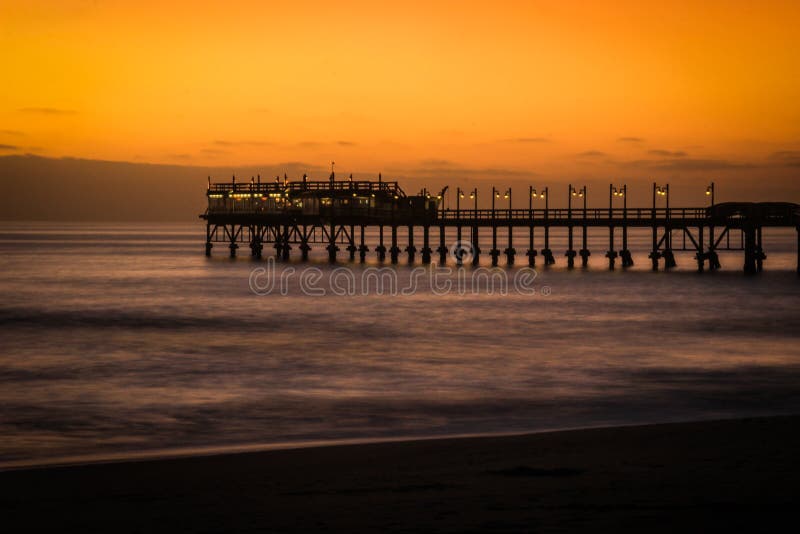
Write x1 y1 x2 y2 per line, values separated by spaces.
200 176 800 274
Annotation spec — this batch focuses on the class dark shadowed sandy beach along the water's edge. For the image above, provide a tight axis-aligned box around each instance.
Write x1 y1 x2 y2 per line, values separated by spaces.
0 416 800 532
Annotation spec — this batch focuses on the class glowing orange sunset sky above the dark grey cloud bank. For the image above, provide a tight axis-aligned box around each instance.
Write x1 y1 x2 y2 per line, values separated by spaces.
0 0 800 179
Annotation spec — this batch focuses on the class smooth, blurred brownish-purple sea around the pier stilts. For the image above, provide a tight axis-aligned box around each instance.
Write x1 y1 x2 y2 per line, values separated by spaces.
0 223 800 466
